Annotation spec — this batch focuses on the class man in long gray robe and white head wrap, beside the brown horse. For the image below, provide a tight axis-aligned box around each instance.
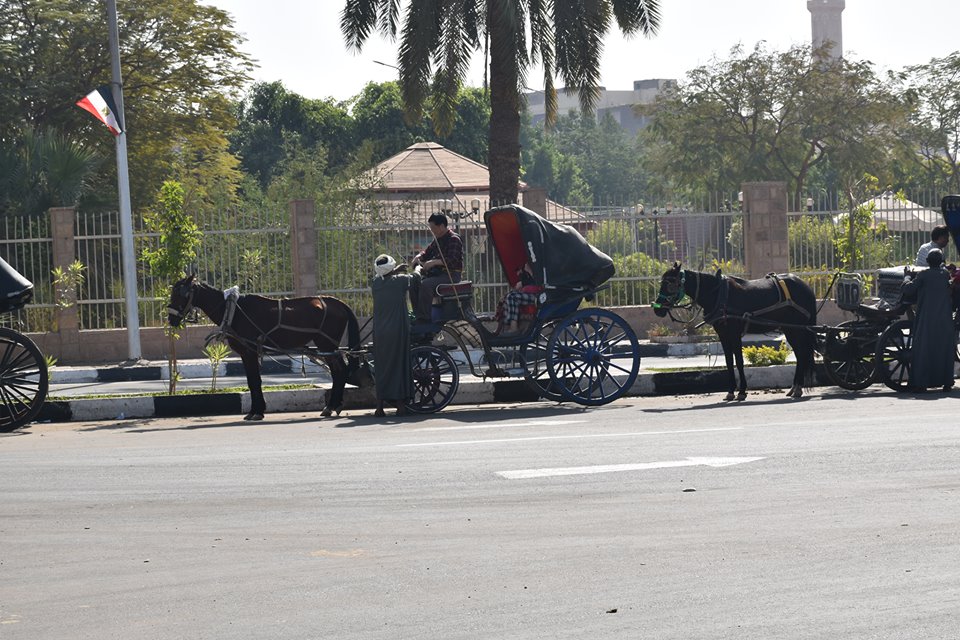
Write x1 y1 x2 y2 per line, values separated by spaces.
370 255 420 417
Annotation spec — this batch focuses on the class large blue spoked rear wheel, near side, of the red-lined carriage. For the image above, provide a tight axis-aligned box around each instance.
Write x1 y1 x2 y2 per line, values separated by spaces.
546 309 640 406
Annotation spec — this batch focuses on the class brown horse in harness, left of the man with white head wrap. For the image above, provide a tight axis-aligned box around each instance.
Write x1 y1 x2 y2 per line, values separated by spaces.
167 275 360 420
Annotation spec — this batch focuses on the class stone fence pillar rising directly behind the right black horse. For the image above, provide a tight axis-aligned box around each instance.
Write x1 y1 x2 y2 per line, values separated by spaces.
741 182 790 278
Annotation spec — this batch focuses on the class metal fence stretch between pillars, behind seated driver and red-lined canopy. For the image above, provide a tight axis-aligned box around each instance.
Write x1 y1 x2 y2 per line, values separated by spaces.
317 203 744 315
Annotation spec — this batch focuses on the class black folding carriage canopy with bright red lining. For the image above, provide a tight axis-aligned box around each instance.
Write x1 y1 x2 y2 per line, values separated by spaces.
483 204 614 290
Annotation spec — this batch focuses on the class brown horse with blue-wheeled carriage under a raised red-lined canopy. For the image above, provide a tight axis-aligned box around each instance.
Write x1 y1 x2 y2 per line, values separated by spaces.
169 205 640 420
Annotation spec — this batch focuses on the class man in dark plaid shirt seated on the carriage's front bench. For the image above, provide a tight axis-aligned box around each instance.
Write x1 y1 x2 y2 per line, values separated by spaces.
410 213 463 324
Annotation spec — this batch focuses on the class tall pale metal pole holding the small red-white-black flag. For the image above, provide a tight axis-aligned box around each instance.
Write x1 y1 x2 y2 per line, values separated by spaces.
107 0 141 360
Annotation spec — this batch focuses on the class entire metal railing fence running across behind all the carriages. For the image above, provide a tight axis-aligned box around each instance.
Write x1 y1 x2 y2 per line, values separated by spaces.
0 192 957 331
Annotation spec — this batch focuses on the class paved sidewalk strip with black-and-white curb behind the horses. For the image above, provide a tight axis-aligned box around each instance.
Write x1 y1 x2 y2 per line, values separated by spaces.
38 336 804 422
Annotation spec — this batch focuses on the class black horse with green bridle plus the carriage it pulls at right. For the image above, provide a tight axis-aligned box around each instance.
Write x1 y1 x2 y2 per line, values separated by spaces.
654 196 960 400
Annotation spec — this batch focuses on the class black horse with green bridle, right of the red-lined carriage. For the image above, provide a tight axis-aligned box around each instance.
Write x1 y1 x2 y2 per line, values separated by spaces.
653 262 817 400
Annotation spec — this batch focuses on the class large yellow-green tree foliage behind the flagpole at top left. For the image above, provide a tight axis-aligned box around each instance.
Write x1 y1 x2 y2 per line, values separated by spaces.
0 0 251 210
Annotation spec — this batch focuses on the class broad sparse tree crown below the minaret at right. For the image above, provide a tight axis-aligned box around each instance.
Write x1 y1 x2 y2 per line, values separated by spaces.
648 44 905 201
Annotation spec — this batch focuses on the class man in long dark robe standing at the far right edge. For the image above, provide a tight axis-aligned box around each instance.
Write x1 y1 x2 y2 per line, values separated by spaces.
903 249 957 391
